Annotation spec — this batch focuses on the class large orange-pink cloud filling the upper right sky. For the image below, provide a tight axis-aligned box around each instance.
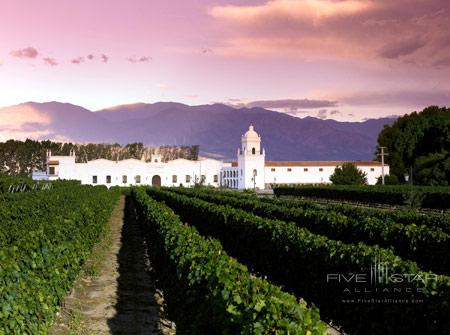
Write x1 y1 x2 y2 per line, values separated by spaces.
210 0 450 67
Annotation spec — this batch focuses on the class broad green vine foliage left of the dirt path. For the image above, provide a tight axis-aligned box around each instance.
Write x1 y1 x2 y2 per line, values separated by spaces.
0 184 119 334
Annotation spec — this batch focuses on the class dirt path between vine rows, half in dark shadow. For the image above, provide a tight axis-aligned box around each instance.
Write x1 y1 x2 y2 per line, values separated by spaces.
51 196 175 335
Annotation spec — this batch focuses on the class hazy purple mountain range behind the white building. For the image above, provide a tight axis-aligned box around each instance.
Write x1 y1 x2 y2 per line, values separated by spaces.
0 102 395 160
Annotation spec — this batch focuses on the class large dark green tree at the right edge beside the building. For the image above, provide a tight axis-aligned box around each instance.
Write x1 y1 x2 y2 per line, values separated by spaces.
378 106 450 185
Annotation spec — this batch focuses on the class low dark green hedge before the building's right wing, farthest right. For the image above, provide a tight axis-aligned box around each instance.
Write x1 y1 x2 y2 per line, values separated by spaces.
274 185 450 209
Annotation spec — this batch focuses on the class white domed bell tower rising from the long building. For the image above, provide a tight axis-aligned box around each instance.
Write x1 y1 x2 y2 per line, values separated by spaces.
237 124 266 189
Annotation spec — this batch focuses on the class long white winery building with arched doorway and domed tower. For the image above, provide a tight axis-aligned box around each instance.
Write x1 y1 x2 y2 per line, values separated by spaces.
40 125 389 189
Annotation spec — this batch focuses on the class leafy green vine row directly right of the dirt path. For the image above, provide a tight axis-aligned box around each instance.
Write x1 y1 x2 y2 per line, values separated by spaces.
132 188 326 335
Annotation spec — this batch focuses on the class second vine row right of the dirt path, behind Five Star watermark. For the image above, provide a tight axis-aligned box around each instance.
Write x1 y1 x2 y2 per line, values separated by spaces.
148 188 450 334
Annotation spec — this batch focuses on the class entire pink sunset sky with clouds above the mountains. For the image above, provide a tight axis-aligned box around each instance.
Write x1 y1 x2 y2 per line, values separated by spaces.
0 0 450 120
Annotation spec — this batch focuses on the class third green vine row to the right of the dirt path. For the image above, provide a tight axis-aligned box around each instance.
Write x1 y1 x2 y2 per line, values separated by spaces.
170 189 450 274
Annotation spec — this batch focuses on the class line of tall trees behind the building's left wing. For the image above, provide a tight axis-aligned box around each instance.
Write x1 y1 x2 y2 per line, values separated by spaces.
0 139 199 176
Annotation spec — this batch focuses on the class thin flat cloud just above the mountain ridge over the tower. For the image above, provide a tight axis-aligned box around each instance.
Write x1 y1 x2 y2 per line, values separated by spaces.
234 99 338 112
